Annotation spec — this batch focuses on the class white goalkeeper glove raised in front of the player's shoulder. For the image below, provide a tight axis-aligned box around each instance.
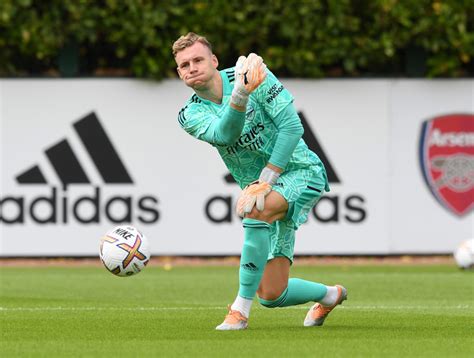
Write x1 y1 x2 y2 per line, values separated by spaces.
231 53 267 107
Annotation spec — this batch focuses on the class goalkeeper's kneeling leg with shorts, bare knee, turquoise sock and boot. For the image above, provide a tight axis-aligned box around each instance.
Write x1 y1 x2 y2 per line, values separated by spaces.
259 166 347 326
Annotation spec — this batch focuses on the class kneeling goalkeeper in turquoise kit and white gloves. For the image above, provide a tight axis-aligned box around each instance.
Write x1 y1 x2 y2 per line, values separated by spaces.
173 32 347 330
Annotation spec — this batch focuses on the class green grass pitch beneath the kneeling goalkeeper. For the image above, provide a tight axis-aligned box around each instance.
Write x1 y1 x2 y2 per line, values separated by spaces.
0 265 474 358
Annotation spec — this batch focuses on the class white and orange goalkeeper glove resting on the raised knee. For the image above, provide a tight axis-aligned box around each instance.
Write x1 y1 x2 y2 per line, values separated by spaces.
237 167 280 218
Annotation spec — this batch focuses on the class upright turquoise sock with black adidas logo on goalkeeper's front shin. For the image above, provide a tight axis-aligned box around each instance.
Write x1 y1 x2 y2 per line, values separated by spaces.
239 218 270 300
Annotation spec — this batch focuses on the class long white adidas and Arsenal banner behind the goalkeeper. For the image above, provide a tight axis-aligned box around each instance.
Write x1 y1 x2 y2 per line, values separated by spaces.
0 79 474 256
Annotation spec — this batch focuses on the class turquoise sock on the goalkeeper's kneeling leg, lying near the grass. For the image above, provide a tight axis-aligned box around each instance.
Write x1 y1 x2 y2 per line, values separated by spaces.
259 278 327 308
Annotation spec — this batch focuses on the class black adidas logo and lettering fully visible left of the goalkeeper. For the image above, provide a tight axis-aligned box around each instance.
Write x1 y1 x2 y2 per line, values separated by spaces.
0 112 159 225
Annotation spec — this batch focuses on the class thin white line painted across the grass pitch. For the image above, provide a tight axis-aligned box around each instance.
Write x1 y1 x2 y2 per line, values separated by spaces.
0 305 472 312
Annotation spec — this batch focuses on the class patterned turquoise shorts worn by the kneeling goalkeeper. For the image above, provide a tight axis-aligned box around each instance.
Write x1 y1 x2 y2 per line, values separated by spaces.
268 165 329 262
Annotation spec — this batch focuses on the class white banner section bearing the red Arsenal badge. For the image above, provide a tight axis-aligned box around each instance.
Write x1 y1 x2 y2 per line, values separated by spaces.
389 80 474 253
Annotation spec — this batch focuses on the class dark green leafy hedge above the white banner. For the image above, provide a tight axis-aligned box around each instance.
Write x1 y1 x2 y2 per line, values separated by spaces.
0 0 474 79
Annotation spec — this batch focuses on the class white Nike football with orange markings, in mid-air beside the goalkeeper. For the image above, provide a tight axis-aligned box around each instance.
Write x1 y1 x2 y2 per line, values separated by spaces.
100 225 150 277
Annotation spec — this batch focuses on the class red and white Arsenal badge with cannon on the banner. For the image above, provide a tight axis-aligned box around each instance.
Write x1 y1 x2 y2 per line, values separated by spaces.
420 114 474 216
